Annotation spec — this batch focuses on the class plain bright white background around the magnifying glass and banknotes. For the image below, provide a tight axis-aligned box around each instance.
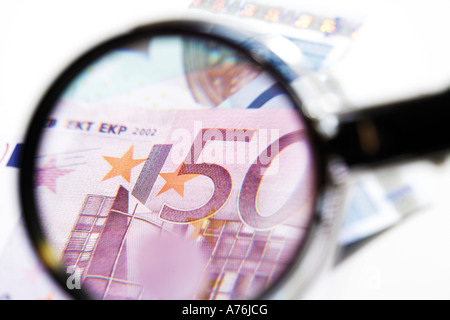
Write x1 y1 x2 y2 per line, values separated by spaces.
0 0 450 299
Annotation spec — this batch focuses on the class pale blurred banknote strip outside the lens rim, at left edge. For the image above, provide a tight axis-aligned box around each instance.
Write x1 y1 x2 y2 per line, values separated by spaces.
0 138 67 300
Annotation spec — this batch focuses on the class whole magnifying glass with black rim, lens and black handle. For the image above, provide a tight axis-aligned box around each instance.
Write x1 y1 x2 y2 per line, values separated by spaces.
20 21 450 299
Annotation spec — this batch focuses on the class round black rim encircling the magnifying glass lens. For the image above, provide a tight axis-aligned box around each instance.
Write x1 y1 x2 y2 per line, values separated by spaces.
19 20 326 299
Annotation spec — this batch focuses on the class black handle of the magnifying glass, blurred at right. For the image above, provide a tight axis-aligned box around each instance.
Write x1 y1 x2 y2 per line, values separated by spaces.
325 89 450 166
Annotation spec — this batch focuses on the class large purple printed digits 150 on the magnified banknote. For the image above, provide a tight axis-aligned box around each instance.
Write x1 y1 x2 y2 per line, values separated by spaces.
133 129 304 229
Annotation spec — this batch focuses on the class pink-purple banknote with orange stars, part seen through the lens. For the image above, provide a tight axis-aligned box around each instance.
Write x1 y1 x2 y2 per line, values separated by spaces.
35 94 317 299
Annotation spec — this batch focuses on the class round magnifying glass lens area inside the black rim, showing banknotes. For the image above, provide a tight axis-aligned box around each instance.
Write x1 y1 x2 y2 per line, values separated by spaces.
27 30 317 299
